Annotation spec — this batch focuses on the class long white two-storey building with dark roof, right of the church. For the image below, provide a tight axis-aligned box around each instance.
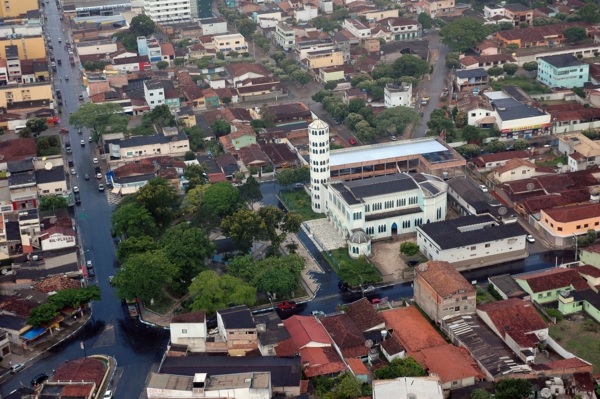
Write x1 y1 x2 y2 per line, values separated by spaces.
416 215 529 270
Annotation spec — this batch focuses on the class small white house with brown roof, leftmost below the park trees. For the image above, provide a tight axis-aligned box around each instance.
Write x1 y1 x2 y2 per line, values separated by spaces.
169 312 208 352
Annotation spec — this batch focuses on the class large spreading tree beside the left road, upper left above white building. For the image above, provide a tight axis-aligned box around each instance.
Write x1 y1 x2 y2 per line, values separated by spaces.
69 102 129 137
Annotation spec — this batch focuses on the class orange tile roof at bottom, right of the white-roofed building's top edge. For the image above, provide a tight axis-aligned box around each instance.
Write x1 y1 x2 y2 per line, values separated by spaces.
414 344 483 384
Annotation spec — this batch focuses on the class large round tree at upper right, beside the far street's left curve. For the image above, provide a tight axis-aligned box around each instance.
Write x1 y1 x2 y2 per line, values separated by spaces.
440 17 490 53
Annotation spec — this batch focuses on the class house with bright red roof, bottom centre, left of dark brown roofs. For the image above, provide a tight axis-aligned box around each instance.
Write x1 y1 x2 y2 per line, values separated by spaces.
276 316 346 378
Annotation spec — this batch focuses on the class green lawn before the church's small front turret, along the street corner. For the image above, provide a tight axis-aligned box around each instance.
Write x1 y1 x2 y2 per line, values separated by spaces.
322 248 382 287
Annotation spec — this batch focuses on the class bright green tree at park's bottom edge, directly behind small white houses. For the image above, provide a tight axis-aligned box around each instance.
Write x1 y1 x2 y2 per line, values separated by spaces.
188 270 256 313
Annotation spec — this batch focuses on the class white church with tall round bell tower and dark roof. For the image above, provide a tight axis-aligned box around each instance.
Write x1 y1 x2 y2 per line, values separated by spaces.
308 120 448 257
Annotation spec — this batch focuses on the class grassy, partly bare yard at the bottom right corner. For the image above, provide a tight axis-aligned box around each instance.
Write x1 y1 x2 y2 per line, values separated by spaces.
550 314 600 373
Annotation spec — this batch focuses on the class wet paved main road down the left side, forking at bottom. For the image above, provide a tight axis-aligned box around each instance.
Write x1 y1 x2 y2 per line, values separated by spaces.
0 2 168 398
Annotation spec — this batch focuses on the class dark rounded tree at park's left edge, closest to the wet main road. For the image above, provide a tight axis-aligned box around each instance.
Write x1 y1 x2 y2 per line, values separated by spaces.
111 202 158 238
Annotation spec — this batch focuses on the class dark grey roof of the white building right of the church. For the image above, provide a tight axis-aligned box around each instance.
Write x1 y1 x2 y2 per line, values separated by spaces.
417 215 527 249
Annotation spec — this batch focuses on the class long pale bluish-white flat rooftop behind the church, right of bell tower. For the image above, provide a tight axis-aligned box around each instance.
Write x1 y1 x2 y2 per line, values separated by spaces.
329 138 448 168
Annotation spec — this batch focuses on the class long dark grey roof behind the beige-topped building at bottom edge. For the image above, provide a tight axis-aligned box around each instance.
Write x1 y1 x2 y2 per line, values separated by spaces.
159 356 302 387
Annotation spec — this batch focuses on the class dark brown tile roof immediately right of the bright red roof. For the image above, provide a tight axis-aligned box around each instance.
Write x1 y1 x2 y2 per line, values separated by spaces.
321 313 369 358
